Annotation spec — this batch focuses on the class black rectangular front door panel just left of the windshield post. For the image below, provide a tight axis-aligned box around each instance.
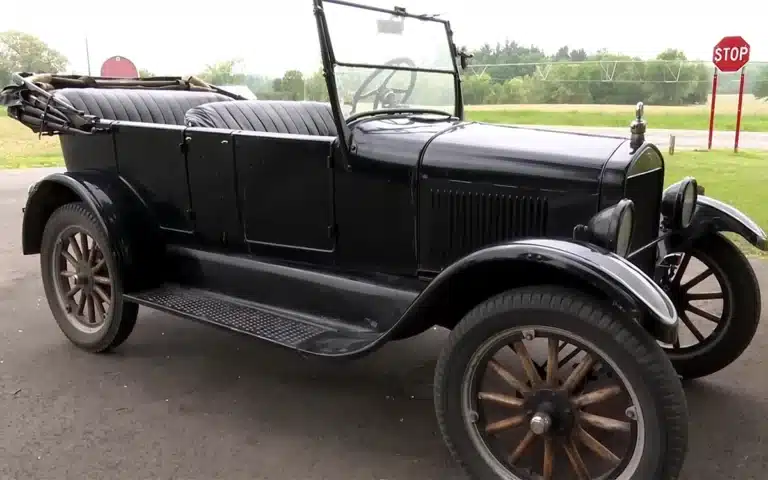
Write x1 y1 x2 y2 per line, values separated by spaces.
233 131 336 256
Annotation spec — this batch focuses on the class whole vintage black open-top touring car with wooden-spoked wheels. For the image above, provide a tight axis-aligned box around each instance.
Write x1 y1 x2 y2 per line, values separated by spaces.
2 0 768 480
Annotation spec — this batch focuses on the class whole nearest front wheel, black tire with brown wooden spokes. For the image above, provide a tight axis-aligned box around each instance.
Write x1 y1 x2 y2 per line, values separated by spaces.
435 287 688 480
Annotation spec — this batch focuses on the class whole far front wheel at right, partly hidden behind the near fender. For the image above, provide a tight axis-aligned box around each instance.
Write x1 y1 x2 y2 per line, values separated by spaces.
660 234 761 378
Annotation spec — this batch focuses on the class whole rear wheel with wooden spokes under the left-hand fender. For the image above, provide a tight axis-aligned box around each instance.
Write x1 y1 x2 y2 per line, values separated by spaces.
40 203 138 352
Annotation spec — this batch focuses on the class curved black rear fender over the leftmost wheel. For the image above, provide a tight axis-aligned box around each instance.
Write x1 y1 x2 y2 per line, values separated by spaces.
21 171 164 292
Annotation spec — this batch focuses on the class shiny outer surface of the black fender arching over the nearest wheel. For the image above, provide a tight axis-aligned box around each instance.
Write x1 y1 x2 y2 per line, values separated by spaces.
394 239 678 343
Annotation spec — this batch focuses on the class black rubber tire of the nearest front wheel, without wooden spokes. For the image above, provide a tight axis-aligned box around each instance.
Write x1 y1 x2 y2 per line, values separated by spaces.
435 286 688 480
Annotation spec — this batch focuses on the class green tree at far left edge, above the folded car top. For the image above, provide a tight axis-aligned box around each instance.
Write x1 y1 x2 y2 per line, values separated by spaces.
0 30 69 85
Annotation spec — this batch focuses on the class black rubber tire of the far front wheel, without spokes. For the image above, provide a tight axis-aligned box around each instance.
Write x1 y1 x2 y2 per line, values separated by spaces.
664 233 761 379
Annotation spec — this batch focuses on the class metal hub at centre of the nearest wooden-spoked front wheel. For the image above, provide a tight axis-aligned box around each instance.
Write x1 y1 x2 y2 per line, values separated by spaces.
523 389 576 436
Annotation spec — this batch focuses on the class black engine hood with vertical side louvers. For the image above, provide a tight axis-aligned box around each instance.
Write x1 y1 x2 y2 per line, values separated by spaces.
419 123 623 272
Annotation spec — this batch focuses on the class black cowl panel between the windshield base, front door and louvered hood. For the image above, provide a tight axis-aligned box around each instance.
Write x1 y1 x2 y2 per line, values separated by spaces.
334 118 455 275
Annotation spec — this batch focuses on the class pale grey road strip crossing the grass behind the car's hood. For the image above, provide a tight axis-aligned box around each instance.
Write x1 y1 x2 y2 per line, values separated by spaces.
516 126 768 152
